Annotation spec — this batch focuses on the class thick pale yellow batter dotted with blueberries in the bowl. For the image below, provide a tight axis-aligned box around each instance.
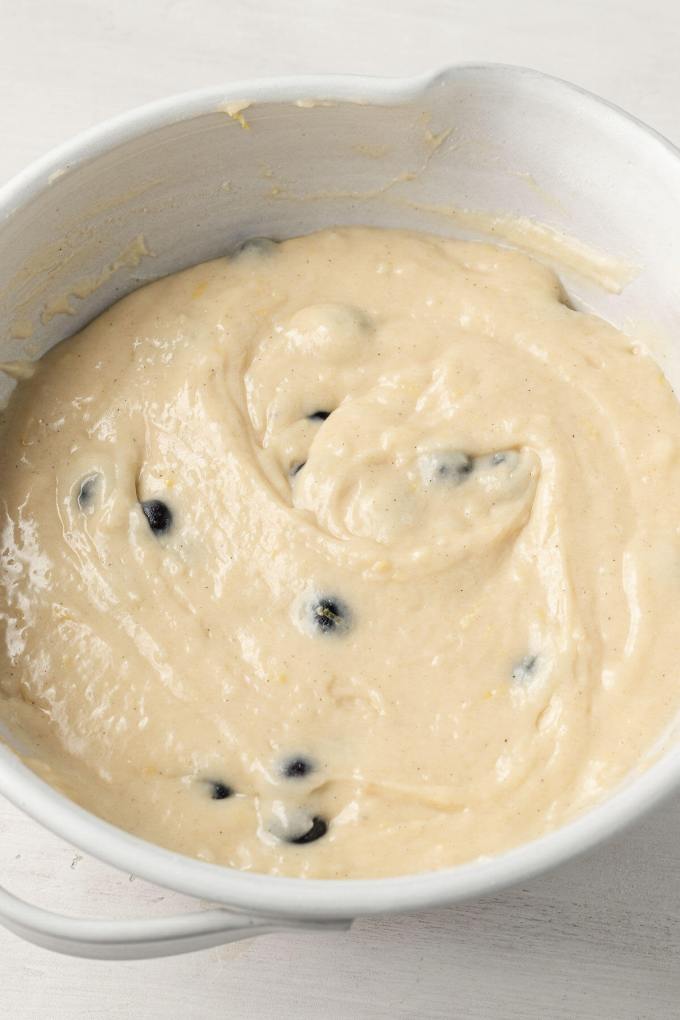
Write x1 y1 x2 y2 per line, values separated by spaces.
0 228 680 877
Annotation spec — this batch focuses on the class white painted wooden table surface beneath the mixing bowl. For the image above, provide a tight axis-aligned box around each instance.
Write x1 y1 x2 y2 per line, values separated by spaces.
0 0 680 1020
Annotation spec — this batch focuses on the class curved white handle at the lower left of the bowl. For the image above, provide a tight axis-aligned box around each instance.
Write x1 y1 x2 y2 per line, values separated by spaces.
0 886 352 960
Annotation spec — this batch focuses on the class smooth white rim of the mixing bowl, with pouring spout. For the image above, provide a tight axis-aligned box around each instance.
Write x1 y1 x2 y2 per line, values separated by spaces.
0 62 680 920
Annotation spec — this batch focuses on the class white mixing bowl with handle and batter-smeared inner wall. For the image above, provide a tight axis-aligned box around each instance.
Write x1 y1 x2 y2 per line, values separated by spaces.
0 65 680 958
